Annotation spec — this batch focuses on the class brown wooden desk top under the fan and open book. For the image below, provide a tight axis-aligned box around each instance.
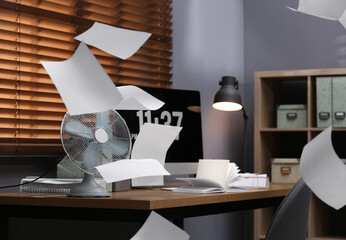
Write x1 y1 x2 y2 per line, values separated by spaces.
0 184 292 210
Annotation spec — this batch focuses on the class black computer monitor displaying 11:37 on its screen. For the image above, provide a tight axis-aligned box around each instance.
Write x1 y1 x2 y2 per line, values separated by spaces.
118 87 203 174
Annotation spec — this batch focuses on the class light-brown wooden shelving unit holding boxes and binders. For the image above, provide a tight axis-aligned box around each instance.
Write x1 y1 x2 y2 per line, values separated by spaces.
254 68 346 240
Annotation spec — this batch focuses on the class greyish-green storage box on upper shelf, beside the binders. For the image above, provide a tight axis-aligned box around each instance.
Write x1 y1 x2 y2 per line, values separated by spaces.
277 104 307 128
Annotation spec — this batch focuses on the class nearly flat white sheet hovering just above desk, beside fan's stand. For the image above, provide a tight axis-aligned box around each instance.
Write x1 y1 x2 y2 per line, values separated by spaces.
96 159 170 183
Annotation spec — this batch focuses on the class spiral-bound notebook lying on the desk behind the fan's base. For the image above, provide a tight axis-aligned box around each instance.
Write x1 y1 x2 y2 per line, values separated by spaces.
19 176 106 194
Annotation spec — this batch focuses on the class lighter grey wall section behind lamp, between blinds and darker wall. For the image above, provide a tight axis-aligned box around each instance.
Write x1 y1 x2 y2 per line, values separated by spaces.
173 0 245 240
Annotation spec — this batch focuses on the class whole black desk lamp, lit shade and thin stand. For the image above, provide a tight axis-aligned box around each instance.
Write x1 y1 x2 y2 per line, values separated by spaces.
213 76 248 171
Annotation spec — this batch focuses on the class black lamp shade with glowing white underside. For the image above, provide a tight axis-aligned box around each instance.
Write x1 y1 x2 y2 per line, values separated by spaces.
213 76 242 111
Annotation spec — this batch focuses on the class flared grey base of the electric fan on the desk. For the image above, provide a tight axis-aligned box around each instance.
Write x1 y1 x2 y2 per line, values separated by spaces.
67 173 110 197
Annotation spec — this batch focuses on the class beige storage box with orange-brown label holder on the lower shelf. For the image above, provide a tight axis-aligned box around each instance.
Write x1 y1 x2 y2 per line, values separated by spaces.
271 158 300 183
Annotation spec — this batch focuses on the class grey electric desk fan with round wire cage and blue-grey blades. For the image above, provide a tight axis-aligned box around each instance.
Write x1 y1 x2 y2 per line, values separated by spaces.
61 110 131 197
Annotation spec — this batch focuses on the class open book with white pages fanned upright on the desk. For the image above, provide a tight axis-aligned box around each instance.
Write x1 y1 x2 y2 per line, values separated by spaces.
173 159 246 193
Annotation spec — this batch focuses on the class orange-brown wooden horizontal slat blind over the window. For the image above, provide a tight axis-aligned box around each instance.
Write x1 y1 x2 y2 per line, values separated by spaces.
0 0 172 155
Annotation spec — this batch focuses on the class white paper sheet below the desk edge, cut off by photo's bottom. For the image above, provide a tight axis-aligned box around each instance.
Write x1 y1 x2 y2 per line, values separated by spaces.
130 211 190 240
